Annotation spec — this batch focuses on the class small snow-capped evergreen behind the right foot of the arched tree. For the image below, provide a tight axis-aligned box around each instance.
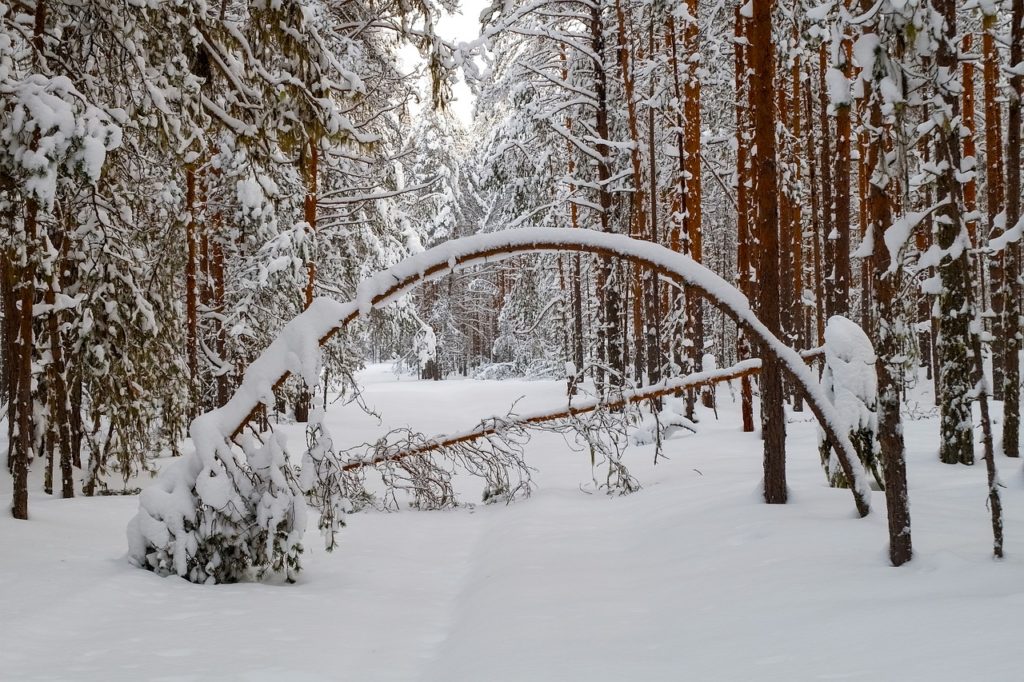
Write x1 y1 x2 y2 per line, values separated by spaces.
819 315 883 487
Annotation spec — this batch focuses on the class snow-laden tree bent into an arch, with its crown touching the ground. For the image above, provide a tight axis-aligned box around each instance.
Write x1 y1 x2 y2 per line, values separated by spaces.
127 227 870 583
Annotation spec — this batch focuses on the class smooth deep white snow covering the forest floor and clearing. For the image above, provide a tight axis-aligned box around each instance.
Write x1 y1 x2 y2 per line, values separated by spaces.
0 366 1024 681
